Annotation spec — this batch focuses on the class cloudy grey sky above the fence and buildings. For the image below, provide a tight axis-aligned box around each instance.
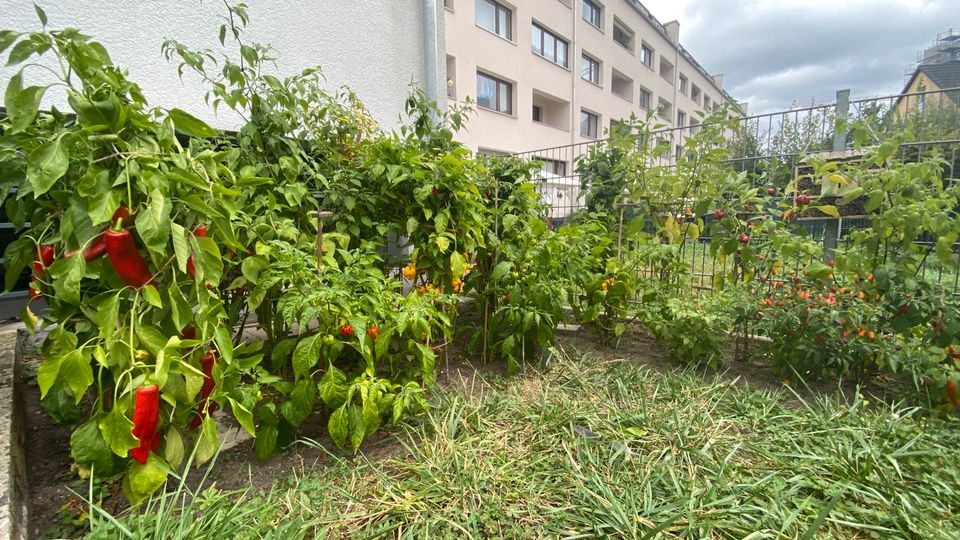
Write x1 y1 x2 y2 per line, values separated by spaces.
641 0 960 114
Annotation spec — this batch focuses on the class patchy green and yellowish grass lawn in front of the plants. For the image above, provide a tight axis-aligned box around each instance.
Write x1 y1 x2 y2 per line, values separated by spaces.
86 353 960 539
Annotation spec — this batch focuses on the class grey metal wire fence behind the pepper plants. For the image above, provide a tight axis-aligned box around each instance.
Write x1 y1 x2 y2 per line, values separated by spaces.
515 88 960 294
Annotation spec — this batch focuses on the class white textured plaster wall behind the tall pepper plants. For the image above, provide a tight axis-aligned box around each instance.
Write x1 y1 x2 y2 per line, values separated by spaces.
0 0 444 129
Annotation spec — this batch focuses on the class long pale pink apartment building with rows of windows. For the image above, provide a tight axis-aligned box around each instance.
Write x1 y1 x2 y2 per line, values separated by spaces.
444 0 744 161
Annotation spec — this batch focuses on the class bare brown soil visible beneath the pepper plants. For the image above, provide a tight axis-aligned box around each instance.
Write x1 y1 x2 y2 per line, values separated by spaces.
24 318 916 537
